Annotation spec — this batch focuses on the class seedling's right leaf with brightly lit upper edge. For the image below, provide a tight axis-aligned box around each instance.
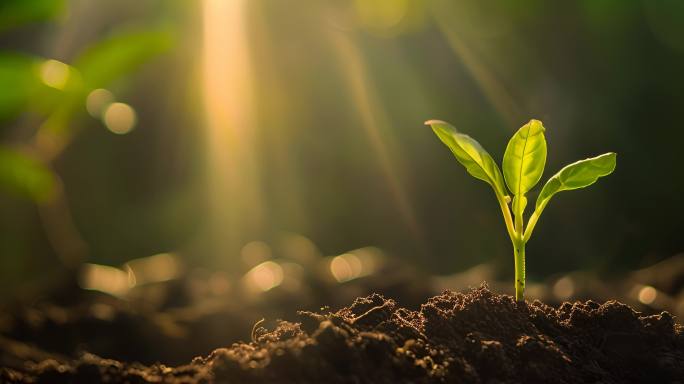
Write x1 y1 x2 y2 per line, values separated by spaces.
535 152 617 211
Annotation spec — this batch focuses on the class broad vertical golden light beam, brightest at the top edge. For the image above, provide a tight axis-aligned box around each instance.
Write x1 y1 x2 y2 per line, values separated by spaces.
202 0 263 254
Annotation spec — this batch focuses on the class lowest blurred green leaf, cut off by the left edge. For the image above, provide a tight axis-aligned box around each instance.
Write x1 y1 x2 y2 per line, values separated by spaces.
0 147 56 202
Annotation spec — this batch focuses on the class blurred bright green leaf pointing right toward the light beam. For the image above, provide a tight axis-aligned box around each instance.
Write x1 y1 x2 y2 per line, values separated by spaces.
74 28 173 88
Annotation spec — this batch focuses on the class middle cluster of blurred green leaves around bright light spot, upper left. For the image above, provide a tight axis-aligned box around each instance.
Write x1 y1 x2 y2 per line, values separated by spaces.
0 27 173 132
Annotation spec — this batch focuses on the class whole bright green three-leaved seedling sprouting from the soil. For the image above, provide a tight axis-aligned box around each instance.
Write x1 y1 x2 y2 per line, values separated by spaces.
425 120 617 301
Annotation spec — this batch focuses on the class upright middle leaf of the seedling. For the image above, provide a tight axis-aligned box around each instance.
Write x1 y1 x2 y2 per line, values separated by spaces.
503 120 546 196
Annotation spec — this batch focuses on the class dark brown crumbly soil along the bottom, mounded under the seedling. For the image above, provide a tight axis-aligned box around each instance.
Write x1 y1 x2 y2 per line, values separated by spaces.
0 286 684 383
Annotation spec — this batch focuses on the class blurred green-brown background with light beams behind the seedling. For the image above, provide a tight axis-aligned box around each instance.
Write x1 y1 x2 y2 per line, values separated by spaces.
0 0 684 364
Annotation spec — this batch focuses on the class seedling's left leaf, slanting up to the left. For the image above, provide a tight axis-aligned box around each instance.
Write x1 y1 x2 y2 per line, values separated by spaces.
425 120 507 198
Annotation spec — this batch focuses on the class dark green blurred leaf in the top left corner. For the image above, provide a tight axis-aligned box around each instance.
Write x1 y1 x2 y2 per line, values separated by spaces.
0 0 64 32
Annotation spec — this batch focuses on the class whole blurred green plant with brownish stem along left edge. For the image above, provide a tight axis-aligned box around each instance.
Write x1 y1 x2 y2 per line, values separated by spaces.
0 0 173 260
